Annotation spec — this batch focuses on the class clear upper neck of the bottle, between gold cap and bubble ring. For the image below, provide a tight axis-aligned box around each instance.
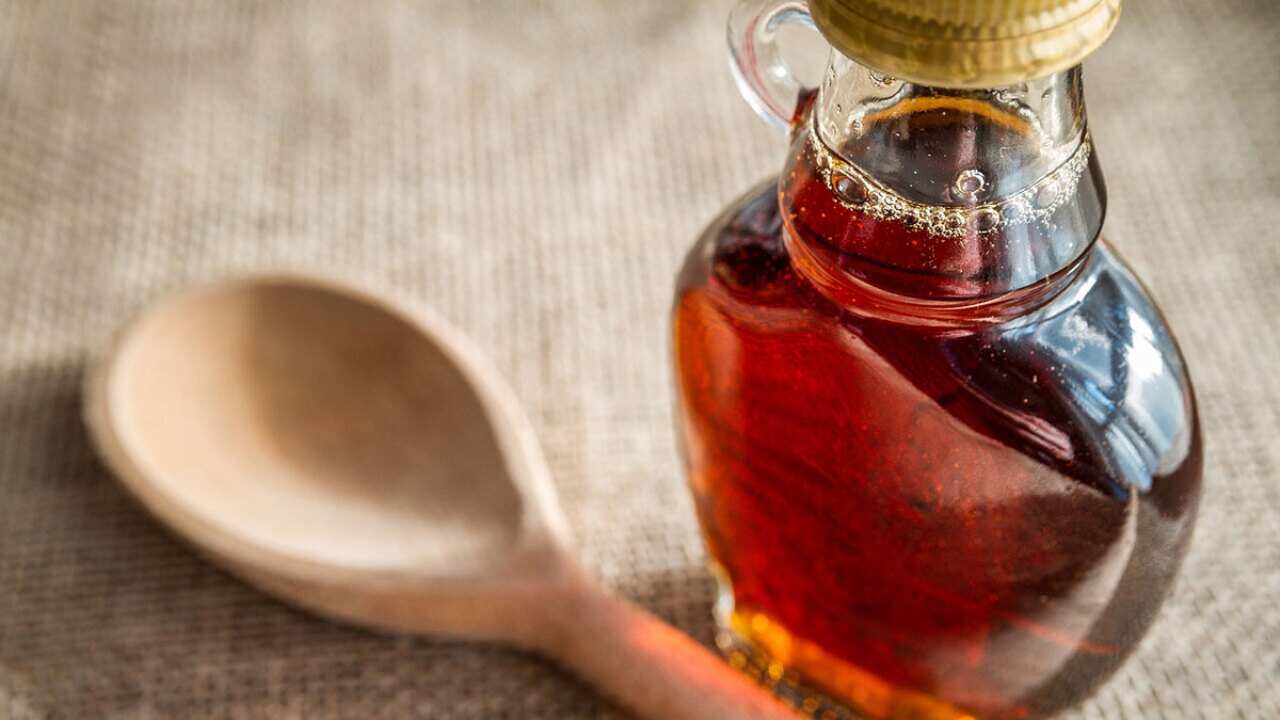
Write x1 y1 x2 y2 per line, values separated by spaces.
814 53 1085 206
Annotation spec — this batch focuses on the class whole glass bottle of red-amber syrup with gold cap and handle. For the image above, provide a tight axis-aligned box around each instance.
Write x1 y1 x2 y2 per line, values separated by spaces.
673 0 1201 720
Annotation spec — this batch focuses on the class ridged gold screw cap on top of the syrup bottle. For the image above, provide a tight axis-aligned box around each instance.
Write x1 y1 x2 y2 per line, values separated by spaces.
809 0 1120 87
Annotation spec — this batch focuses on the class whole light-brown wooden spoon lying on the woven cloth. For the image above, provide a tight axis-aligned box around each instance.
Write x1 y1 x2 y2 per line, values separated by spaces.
86 278 796 720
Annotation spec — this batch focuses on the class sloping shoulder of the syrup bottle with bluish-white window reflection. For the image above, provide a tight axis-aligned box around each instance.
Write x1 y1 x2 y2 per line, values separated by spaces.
676 182 1199 504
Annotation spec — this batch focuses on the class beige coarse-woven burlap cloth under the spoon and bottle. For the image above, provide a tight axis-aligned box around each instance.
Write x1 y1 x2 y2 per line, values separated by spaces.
0 0 1280 719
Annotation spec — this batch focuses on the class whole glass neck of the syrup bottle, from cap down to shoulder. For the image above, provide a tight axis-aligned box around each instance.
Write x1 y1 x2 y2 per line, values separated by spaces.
782 54 1105 322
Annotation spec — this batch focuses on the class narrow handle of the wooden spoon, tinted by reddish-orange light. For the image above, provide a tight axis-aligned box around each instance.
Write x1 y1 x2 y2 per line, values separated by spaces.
545 587 800 720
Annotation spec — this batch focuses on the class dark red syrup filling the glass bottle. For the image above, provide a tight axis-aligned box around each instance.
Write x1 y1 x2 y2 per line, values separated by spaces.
675 114 1201 719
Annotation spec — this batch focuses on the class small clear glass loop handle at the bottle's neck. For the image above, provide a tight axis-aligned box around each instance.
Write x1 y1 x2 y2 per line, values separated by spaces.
728 0 817 131
